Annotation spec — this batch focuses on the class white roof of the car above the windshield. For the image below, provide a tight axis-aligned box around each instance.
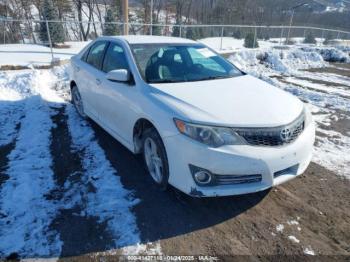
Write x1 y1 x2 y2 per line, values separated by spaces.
99 35 197 44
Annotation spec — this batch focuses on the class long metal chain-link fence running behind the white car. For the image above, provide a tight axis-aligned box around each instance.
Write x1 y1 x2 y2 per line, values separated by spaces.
0 18 350 63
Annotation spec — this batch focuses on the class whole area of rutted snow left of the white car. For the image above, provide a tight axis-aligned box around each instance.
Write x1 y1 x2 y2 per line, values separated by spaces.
0 68 157 258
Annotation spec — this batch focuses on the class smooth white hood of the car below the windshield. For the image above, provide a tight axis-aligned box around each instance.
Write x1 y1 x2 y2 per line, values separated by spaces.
151 75 303 127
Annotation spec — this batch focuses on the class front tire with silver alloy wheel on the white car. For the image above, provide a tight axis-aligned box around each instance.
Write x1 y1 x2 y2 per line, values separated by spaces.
142 128 169 191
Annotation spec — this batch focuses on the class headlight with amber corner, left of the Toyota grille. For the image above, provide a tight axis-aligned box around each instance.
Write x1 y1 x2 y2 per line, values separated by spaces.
174 119 246 147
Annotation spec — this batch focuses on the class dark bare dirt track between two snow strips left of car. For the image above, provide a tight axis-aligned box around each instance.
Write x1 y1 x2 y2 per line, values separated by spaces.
47 107 114 257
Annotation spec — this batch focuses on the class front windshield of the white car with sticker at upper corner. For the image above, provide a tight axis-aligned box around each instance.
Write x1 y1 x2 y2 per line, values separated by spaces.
130 44 243 83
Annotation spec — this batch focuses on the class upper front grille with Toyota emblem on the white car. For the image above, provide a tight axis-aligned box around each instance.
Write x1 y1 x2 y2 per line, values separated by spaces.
234 112 305 146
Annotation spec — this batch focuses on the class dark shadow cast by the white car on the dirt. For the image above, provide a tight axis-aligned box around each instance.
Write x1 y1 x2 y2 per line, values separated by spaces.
91 121 269 243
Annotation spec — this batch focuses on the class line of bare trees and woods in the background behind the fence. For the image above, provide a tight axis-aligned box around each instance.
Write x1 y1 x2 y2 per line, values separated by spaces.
0 0 350 43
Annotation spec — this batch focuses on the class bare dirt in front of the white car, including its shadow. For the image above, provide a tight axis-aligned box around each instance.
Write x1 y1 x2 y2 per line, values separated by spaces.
73 120 350 256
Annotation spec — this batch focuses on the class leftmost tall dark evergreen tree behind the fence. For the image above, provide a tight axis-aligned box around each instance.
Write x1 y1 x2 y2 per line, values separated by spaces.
40 0 64 45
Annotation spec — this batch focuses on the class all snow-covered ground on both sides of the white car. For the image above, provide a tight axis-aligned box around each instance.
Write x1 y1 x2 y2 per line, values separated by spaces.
0 37 350 257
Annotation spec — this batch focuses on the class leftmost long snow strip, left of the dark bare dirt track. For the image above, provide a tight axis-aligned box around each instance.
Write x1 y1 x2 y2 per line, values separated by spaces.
0 72 61 257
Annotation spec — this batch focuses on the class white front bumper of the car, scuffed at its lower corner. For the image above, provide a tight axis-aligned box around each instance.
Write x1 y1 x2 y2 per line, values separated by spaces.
164 123 315 197
